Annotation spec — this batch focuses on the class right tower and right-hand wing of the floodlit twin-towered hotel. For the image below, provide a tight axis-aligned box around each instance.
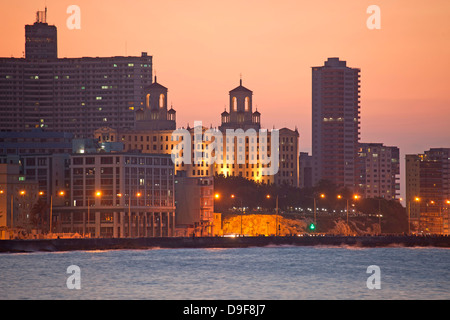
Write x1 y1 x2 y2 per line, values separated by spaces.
214 80 299 187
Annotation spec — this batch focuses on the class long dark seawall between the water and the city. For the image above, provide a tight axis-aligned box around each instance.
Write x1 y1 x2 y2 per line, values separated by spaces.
0 236 450 253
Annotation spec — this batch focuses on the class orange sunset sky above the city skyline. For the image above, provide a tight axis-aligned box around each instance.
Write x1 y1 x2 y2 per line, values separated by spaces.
0 0 450 198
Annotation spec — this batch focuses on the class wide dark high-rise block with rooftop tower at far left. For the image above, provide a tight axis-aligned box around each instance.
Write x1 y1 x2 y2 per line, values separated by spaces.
0 9 152 138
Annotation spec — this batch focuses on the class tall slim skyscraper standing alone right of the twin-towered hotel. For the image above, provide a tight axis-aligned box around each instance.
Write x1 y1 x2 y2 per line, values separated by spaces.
312 58 360 190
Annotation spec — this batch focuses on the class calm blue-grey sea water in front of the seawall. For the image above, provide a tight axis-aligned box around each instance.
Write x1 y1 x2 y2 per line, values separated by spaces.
0 247 450 300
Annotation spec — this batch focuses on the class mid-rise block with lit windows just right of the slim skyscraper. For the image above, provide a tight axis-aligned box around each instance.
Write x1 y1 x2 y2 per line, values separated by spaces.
358 143 400 200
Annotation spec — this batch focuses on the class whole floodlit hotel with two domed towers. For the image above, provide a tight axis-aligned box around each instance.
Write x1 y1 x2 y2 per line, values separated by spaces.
94 79 299 187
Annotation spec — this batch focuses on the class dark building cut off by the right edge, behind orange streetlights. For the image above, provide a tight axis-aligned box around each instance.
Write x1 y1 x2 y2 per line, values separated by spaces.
405 148 450 235
